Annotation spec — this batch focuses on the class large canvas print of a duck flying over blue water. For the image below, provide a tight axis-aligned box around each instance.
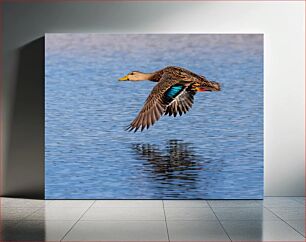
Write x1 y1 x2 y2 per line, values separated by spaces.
45 33 263 199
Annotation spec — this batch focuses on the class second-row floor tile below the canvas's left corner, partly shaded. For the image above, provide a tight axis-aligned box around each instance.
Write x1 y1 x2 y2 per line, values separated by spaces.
26 207 87 220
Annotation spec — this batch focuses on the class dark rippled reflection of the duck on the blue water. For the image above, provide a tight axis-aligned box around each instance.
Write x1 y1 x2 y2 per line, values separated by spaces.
133 140 202 182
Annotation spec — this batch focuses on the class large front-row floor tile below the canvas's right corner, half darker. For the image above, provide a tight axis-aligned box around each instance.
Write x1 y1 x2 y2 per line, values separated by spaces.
221 220 304 241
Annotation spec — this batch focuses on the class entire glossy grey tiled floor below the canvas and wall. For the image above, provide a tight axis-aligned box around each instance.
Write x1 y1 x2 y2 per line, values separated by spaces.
0 197 305 241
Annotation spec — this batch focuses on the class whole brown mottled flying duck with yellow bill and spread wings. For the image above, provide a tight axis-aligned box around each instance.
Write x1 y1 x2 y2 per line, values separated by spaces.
119 66 221 132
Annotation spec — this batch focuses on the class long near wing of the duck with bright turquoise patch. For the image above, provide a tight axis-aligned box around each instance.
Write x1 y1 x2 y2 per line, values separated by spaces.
126 73 190 132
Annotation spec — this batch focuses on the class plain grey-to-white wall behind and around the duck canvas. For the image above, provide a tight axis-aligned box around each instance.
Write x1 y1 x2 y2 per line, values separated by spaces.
2 1 305 196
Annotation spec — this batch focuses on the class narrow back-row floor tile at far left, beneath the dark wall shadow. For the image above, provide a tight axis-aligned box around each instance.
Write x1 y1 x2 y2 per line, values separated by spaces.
0 197 45 208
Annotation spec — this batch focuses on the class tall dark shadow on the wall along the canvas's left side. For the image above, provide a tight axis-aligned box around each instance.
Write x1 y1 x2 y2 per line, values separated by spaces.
3 37 45 199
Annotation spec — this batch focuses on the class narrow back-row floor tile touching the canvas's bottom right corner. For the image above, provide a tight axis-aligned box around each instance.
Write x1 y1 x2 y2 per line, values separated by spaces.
207 200 263 208
